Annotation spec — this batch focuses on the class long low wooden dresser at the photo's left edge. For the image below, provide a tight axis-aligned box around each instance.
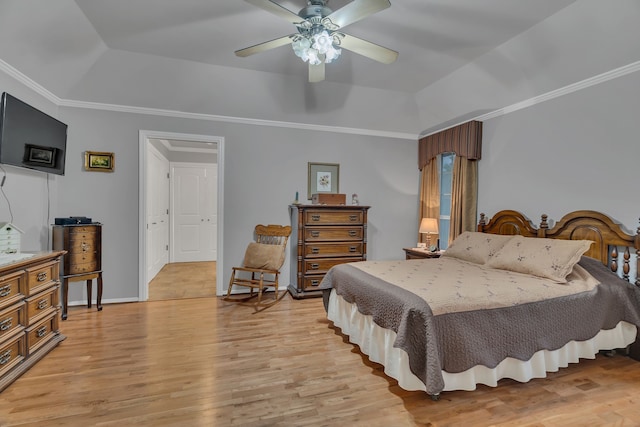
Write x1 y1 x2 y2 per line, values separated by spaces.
0 251 65 391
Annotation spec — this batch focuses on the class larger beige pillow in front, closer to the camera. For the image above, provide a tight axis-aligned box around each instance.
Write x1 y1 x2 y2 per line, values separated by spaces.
486 236 593 283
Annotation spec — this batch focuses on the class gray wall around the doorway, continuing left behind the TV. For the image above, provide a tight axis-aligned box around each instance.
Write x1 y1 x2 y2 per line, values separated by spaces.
0 71 419 302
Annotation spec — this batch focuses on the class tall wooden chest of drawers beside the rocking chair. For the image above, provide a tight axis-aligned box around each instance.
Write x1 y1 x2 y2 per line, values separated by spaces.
289 205 369 298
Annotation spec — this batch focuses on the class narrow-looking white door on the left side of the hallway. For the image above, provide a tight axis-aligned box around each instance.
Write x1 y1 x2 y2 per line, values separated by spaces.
146 145 169 282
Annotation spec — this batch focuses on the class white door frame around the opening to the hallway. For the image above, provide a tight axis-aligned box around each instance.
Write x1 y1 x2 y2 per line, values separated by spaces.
138 130 224 301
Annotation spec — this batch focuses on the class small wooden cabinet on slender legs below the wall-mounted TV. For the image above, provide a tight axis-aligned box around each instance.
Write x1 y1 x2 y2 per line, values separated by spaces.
53 222 102 320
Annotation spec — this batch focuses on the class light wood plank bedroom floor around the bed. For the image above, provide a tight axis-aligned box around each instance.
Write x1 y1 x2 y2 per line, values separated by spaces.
0 295 640 427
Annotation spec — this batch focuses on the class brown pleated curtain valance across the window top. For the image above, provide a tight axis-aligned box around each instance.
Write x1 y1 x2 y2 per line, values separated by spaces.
418 120 482 170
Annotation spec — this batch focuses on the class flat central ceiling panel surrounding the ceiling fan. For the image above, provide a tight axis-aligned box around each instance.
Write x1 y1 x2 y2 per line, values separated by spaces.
75 0 575 93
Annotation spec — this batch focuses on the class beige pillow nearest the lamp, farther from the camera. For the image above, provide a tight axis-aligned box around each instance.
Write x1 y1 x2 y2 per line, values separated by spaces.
442 231 513 264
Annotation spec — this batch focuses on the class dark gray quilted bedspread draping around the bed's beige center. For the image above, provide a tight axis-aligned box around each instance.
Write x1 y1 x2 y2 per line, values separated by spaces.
321 257 640 395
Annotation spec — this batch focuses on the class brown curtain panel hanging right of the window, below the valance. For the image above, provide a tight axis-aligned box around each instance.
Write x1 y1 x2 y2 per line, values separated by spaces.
448 156 478 242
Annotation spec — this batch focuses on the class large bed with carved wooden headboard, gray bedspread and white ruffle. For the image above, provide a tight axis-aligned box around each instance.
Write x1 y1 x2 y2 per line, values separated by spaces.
321 210 640 400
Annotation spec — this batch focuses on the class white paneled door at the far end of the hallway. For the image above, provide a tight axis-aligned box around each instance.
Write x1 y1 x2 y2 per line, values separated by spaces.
171 163 218 262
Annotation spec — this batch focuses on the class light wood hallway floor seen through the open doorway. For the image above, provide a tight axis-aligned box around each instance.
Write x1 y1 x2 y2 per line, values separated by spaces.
149 261 216 301
